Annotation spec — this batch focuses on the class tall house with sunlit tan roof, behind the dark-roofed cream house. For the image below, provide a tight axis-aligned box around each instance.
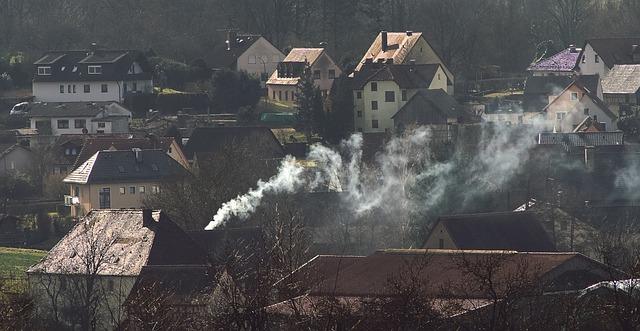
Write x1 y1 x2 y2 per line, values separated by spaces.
354 31 454 95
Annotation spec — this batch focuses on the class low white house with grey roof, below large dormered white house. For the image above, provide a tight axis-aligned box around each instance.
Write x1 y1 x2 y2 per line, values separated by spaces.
28 102 131 136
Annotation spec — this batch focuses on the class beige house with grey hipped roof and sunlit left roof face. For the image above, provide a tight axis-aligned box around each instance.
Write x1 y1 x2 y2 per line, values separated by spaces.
64 149 186 217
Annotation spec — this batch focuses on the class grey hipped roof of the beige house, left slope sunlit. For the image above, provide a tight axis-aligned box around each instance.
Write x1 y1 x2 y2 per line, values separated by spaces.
64 149 186 184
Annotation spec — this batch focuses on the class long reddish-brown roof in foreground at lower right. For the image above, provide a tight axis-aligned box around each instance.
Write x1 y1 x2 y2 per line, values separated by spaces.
310 249 611 299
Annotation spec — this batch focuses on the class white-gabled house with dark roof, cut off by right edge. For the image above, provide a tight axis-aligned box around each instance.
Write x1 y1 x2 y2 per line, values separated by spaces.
577 37 640 78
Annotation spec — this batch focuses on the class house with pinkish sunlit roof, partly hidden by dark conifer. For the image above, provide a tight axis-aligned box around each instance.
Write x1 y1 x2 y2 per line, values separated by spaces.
267 48 342 105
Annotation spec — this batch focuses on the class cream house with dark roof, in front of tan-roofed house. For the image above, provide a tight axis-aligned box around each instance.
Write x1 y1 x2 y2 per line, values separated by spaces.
352 62 448 133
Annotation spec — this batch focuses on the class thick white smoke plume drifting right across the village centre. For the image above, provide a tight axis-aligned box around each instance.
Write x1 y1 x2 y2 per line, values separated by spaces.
206 125 540 230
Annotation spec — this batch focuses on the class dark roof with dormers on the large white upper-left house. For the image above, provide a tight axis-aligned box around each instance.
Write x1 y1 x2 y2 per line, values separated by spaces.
33 49 152 82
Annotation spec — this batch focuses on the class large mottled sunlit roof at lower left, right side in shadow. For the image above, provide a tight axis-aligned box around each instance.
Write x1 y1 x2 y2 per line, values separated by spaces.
27 209 207 276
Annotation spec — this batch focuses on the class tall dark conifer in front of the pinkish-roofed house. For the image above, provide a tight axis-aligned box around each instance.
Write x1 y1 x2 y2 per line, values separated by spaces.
296 66 325 142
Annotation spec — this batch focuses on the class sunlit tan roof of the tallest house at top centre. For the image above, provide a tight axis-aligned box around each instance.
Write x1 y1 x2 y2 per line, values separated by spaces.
355 32 422 71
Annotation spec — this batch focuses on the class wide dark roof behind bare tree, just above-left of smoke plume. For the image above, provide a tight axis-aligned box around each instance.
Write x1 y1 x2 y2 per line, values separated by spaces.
184 127 284 160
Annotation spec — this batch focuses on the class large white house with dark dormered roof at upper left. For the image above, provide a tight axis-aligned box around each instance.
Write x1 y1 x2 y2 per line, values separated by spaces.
32 45 153 102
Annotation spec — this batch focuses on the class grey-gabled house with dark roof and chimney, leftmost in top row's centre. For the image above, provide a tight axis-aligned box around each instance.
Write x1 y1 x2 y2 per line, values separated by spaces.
207 31 284 85
